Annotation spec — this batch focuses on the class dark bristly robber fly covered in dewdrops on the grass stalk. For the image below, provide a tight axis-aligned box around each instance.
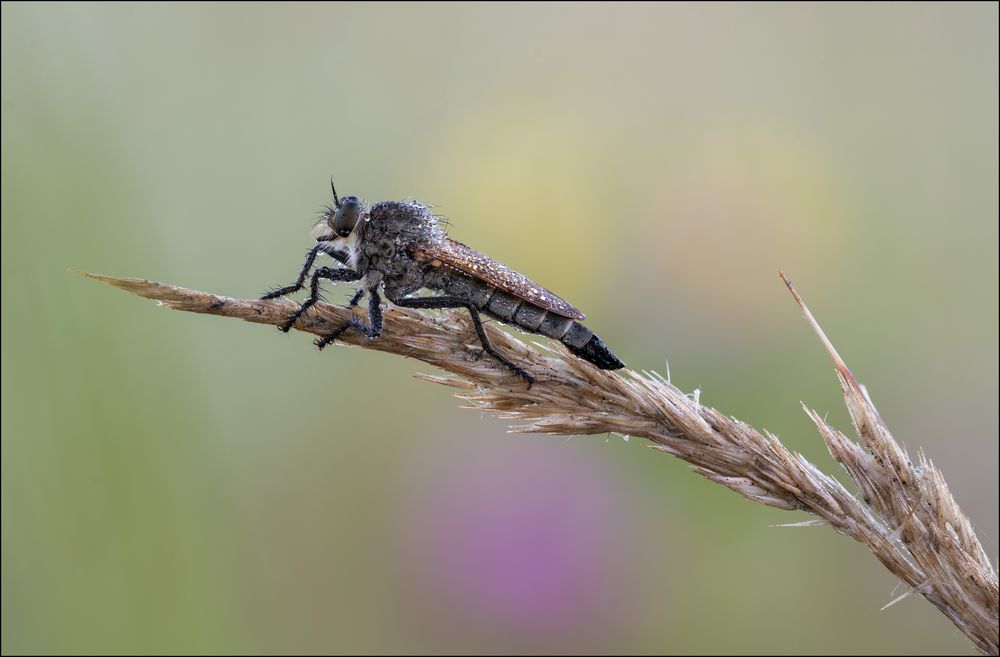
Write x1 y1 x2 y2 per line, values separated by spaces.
263 180 625 384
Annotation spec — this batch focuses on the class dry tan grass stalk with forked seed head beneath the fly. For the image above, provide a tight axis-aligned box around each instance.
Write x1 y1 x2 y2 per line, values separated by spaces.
86 274 998 655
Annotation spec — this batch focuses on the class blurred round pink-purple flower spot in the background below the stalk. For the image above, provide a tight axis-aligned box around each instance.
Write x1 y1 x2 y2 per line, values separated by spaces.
398 430 634 639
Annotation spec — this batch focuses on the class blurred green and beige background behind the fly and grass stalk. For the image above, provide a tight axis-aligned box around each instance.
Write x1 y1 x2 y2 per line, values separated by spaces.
2 3 998 654
